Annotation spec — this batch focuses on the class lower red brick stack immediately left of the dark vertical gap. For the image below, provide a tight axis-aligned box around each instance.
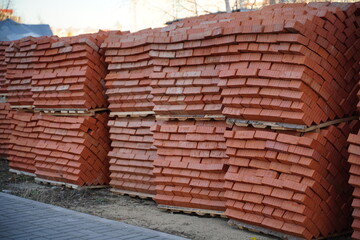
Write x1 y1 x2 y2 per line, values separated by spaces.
32 113 110 186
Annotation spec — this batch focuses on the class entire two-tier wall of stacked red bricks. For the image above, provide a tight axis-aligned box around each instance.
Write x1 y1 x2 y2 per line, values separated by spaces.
0 3 360 239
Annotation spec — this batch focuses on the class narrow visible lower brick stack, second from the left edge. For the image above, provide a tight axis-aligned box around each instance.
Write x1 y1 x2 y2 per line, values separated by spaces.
7 111 38 174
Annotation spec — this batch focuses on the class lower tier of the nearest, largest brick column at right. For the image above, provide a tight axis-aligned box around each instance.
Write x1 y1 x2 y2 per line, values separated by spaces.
225 121 359 239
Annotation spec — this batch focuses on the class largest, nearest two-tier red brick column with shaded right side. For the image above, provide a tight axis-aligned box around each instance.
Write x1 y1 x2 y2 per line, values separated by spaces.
214 3 359 239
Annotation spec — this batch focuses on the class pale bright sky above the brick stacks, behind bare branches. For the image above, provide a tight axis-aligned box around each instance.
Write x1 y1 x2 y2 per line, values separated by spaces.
9 0 225 34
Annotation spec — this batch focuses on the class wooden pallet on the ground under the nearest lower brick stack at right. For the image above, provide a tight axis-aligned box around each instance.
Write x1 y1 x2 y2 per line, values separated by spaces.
228 219 352 240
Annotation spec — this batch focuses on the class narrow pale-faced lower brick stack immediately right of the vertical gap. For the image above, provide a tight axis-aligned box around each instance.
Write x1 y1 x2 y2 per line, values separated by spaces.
108 117 156 195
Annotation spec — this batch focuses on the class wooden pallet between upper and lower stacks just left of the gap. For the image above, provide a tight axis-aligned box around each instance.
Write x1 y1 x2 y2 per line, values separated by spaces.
35 108 108 116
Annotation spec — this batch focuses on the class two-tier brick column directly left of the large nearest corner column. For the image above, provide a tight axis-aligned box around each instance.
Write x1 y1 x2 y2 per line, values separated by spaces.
146 16 233 212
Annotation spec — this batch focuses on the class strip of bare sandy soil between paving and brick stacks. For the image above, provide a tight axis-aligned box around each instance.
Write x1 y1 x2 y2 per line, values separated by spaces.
0 160 276 240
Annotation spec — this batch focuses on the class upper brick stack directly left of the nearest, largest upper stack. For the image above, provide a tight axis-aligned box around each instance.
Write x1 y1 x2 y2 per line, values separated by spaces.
151 14 231 116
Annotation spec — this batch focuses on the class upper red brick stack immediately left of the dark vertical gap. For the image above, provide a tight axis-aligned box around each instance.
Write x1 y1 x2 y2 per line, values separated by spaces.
31 32 107 109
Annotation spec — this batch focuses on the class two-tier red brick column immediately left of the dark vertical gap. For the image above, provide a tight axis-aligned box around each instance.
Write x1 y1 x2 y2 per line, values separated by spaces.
31 32 110 186
